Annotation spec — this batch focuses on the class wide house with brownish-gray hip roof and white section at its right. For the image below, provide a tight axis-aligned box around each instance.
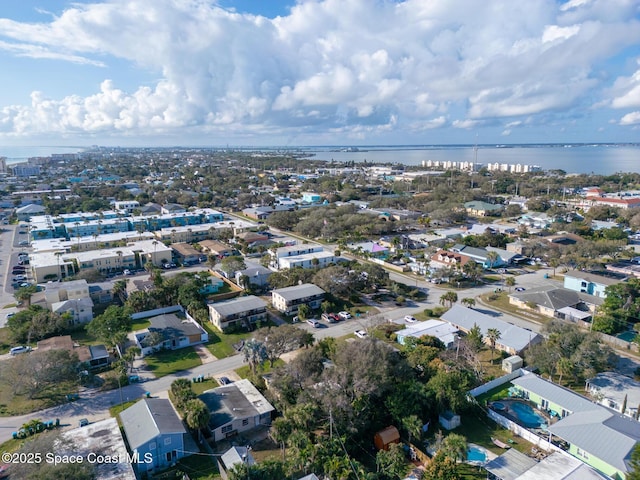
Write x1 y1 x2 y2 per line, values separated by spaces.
509 285 603 322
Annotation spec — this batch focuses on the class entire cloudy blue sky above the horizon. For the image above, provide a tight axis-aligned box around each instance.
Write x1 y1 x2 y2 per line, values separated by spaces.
0 0 640 147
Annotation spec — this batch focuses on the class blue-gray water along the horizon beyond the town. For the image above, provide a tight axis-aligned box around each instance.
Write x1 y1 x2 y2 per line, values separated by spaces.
0 144 640 175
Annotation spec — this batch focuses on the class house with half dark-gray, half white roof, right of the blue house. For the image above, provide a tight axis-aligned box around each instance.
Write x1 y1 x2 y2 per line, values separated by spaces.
198 379 275 442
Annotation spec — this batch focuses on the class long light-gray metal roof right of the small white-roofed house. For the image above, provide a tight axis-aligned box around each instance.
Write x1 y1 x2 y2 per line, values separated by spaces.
440 304 542 355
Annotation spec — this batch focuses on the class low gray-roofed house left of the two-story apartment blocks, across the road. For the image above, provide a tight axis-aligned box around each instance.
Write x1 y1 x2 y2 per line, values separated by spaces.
135 313 209 355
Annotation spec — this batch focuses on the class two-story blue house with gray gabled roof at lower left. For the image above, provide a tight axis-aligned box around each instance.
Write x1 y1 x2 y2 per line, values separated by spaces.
120 398 188 474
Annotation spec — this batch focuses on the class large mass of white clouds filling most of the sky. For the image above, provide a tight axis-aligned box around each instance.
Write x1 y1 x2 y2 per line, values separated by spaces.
0 0 640 138
